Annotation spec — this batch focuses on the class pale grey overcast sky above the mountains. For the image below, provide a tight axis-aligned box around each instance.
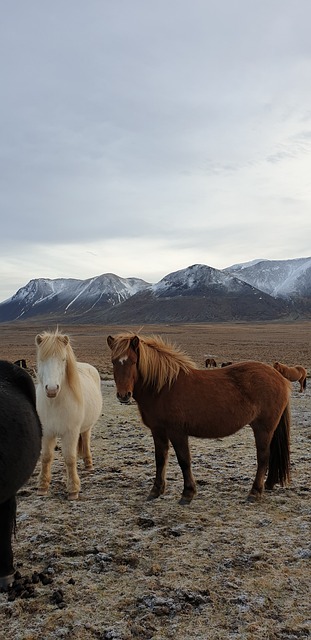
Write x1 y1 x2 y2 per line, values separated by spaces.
0 0 311 301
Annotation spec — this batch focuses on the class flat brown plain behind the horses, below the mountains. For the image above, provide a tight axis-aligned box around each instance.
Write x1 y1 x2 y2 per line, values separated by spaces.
0 321 311 374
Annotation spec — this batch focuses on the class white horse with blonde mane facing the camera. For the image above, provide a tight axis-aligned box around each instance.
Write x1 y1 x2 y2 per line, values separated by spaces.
35 330 102 500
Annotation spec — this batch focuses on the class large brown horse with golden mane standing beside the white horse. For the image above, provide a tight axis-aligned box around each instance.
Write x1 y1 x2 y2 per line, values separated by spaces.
107 334 291 504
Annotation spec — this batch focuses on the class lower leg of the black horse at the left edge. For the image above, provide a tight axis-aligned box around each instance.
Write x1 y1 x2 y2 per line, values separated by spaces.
0 496 16 589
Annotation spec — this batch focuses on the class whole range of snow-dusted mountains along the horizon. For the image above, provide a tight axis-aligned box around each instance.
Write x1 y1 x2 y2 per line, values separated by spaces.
0 258 311 324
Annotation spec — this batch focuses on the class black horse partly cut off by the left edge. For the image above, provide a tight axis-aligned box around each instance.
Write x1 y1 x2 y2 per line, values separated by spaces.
0 360 41 588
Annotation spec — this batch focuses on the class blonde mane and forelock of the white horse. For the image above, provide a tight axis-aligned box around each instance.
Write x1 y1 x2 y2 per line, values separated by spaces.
37 329 81 399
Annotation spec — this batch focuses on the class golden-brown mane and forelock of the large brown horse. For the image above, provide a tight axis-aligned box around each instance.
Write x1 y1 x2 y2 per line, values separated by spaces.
112 334 198 393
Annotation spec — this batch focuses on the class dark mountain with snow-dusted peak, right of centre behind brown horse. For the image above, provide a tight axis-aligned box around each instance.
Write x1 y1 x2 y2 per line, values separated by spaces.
87 264 290 324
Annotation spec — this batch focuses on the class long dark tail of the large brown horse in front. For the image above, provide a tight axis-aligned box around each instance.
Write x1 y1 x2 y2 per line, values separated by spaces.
266 404 291 489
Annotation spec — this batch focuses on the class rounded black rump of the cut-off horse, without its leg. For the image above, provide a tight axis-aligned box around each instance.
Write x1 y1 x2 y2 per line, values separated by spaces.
0 360 42 503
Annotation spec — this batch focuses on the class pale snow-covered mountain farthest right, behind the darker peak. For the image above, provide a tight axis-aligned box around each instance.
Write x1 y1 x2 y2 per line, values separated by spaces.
224 258 311 298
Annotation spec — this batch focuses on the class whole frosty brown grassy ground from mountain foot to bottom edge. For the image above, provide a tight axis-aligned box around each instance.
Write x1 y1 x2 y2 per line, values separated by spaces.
0 323 311 640
